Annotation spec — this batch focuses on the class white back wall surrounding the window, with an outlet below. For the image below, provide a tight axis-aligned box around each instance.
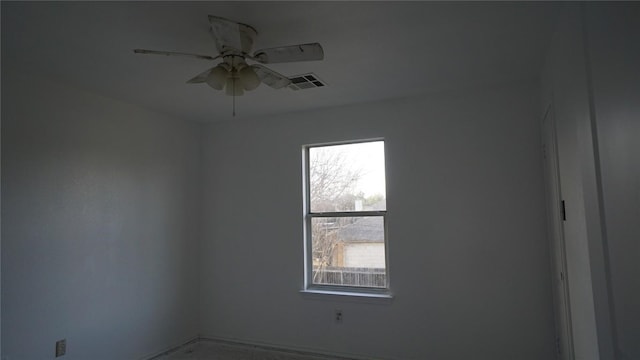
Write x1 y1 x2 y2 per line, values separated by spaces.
201 84 554 360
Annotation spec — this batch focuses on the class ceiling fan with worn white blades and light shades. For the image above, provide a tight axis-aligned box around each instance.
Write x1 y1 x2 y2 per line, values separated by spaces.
133 15 324 97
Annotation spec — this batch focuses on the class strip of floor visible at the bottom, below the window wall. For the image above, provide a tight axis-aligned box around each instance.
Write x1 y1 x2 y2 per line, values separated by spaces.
154 341 348 360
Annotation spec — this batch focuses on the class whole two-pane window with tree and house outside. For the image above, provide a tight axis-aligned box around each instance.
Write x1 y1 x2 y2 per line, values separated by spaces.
304 140 389 293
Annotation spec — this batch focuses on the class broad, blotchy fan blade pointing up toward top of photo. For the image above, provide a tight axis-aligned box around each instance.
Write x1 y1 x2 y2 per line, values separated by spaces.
209 15 258 53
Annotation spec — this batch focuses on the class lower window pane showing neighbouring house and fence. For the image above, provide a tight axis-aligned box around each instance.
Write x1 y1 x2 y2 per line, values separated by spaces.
311 216 387 288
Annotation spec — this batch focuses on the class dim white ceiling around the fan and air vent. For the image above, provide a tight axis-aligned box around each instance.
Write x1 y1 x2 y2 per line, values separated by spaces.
2 1 554 121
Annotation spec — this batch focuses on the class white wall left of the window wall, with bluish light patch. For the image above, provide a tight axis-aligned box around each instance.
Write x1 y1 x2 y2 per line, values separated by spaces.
2 73 201 360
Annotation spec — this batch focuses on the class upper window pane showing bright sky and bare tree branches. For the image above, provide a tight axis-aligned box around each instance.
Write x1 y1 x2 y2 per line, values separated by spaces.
309 141 387 213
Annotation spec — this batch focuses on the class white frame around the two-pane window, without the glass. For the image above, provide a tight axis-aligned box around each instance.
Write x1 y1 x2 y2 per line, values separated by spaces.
302 138 392 298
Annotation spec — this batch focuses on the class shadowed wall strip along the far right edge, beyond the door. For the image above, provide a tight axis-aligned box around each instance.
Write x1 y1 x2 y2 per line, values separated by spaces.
585 3 640 360
